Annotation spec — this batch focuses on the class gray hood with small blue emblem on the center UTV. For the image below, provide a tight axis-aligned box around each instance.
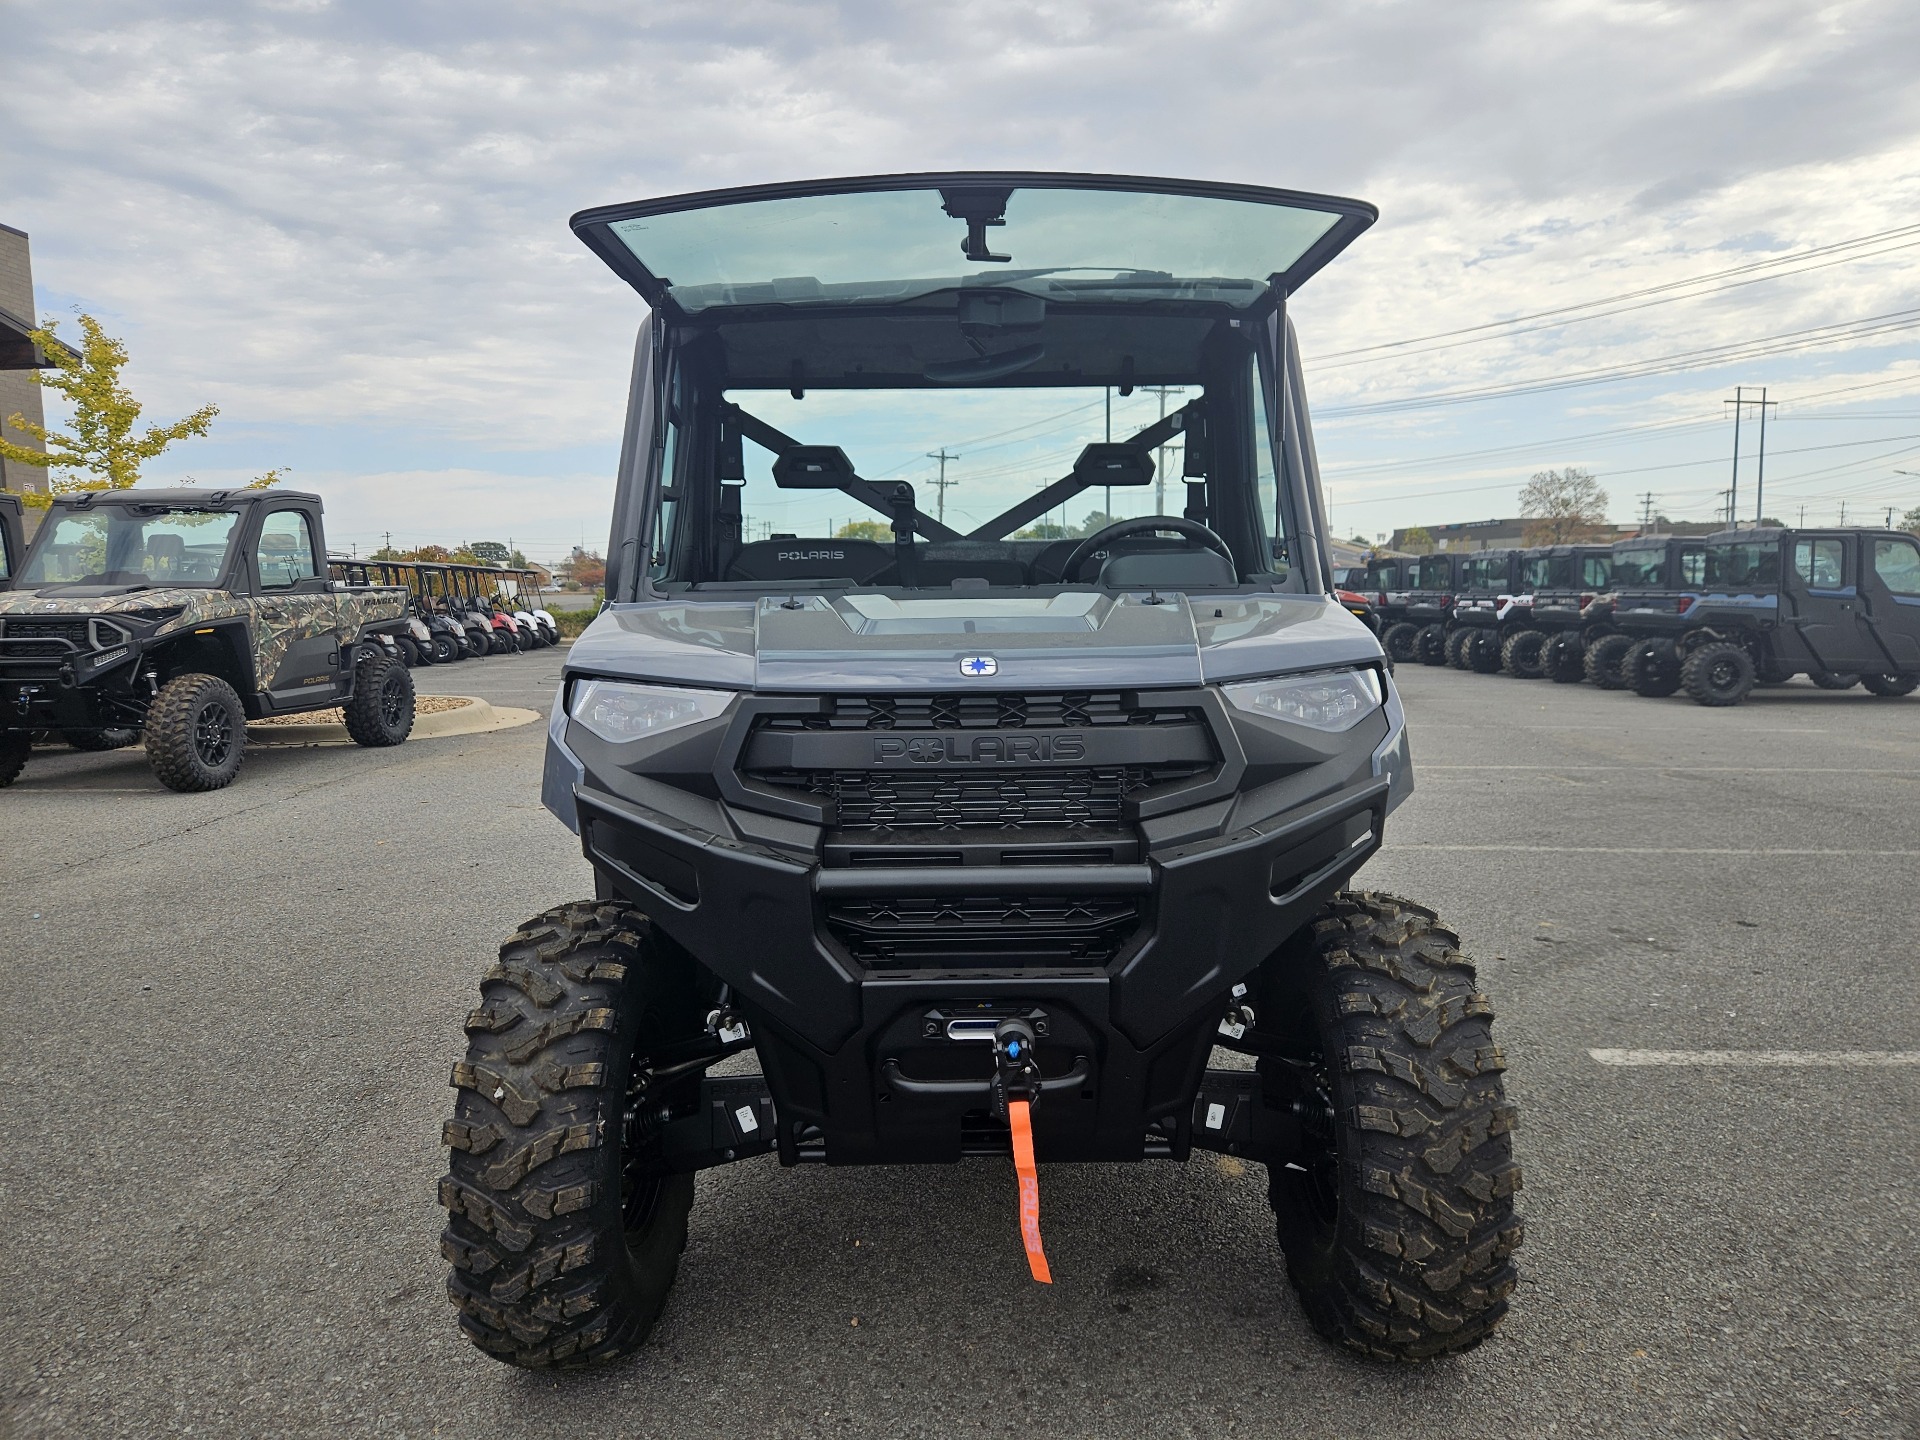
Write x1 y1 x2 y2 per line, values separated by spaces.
568 591 1380 693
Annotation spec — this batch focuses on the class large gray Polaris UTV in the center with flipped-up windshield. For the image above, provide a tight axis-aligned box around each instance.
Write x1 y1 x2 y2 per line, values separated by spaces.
442 173 1521 1365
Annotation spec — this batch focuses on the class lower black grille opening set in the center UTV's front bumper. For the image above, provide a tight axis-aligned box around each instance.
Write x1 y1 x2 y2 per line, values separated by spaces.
826 895 1140 970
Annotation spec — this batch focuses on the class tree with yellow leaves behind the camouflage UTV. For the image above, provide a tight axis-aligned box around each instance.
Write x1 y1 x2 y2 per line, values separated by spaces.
0 315 286 509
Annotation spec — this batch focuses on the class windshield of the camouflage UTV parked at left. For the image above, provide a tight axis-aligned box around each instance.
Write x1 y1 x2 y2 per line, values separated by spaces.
19 505 240 588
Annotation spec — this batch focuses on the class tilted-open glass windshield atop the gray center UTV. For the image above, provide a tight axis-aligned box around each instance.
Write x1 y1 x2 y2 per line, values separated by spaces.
607 184 1350 313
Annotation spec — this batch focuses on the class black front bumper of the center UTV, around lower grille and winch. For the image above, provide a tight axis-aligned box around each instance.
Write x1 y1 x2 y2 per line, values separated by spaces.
574 776 1390 1164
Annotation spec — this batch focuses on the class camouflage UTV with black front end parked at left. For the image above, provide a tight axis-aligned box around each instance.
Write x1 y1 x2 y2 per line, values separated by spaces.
0 490 413 791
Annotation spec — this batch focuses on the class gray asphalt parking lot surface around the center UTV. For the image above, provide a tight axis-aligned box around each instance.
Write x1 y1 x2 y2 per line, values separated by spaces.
0 651 1920 1440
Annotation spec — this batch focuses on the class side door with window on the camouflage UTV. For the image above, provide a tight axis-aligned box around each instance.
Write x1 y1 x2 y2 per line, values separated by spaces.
253 511 340 707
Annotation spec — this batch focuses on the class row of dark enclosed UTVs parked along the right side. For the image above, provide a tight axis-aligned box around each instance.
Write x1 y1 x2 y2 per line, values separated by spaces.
1348 528 1920 705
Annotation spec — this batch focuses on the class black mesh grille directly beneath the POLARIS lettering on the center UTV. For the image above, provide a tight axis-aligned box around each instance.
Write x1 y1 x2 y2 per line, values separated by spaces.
755 764 1206 831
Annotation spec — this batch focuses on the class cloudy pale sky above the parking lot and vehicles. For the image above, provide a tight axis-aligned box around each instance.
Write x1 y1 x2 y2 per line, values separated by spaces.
0 0 1920 559
